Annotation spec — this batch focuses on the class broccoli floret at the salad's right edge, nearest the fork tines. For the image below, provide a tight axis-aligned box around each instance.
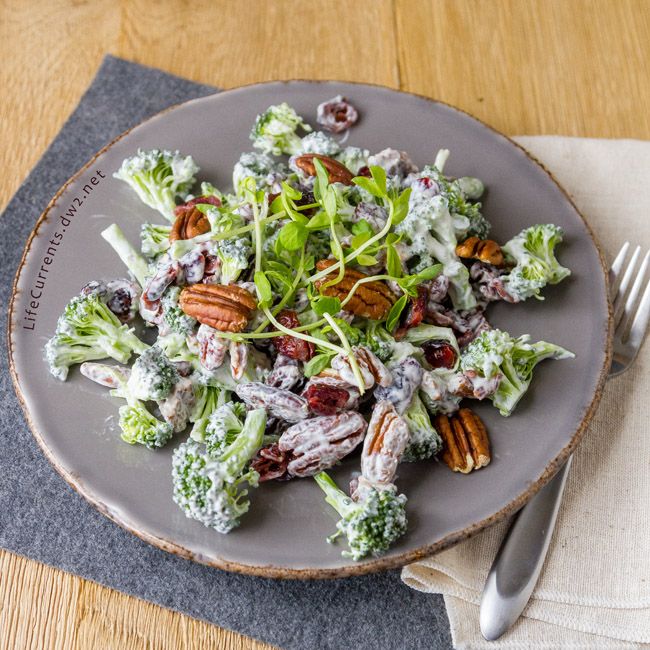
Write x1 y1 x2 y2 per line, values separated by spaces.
502 223 571 300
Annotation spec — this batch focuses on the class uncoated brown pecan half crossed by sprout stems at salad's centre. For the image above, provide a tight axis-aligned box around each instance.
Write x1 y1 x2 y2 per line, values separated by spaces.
314 260 395 320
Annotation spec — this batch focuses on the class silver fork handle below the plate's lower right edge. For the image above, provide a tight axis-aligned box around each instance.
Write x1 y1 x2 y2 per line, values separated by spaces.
479 456 573 641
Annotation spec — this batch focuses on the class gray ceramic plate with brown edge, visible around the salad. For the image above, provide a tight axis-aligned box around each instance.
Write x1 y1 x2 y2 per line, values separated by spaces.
10 81 609 577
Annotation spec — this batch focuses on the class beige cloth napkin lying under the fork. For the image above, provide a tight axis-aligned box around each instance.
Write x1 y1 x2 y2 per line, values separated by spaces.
402 136 650 650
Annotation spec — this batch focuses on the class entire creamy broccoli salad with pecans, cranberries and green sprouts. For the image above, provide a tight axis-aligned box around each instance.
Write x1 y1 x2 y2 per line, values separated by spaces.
45 96 573 560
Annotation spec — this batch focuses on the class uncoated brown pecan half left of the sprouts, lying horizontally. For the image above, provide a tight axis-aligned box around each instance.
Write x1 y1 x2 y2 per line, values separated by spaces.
178 284 257 332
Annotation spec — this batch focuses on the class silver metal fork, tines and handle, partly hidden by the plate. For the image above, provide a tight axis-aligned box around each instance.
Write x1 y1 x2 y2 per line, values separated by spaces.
479 242 650 641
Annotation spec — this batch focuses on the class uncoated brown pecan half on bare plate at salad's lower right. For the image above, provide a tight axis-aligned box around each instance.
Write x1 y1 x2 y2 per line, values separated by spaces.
434 408 490 474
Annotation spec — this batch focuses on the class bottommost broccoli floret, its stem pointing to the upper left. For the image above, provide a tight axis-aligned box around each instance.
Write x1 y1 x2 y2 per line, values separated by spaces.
314 472 407 560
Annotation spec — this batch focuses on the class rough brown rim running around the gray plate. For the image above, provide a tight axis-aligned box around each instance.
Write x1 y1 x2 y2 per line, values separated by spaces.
6 78 614 579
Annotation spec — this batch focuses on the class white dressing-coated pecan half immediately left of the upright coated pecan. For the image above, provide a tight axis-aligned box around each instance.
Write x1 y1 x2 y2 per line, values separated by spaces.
278 411 367 476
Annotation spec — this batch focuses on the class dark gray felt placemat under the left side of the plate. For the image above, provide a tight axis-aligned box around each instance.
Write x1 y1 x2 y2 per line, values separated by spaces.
0 56 451 650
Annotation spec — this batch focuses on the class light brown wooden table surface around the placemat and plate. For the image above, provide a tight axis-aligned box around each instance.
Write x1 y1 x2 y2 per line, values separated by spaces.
0 0 650 650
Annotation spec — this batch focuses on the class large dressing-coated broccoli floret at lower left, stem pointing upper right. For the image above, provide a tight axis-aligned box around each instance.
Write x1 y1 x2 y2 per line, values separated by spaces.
172 409 266 533
